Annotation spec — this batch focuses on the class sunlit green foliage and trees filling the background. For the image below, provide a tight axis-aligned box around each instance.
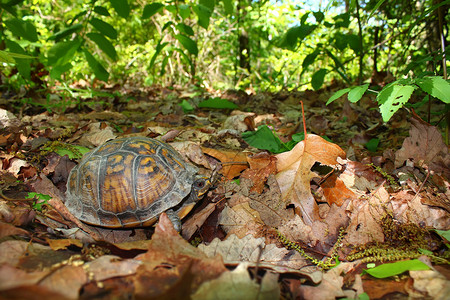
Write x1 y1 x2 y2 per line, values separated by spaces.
0 0 450 91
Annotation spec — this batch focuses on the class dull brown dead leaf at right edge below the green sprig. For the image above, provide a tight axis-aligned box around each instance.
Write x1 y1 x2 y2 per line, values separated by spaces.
395 116 450 178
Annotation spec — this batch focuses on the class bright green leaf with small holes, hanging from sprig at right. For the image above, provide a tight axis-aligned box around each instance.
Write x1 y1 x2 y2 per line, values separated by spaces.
377 84 415 122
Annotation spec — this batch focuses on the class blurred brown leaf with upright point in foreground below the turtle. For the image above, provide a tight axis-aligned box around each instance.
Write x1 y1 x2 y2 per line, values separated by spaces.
132 213 228 299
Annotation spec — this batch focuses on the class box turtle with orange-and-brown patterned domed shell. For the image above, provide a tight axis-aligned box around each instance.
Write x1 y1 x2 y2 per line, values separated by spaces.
65 137 211 231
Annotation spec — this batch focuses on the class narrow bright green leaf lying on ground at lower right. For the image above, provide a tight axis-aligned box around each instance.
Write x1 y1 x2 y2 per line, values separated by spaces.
364 259 430 278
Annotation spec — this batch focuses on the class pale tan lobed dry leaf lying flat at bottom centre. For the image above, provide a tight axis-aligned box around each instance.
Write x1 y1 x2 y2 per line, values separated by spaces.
198 234 322 283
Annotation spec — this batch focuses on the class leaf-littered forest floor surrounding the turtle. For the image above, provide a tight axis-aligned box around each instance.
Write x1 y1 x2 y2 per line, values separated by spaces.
0 83 450 299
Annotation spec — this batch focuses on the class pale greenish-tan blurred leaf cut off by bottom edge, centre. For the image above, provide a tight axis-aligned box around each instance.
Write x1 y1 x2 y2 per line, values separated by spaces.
192 263 280 300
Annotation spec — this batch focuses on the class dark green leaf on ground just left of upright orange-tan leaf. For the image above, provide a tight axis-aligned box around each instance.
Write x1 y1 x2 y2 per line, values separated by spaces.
242 125 283 153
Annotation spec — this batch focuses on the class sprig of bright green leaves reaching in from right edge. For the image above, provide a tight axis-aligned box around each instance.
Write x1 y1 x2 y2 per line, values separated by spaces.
327 76 450 122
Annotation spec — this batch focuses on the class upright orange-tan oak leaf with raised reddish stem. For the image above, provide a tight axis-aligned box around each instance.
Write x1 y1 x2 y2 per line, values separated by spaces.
276 134 346 226
